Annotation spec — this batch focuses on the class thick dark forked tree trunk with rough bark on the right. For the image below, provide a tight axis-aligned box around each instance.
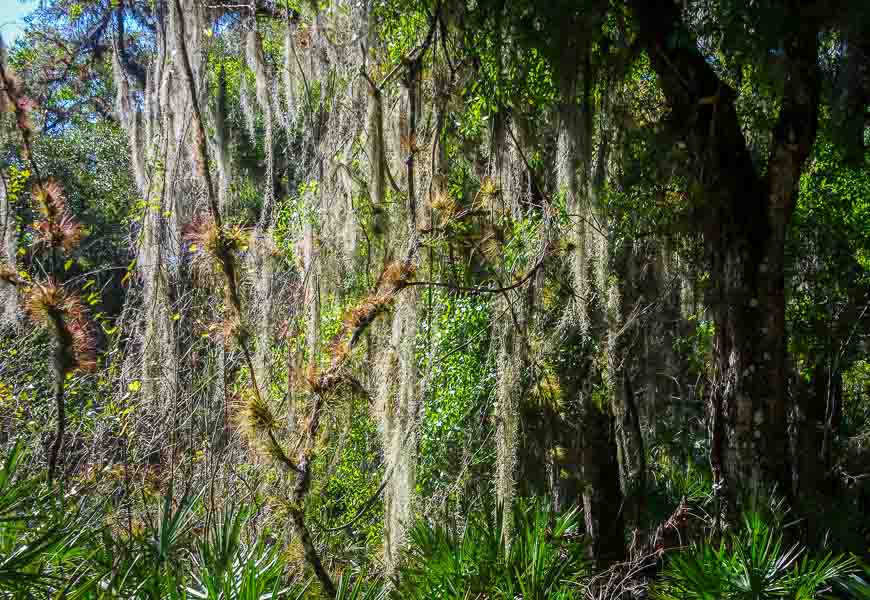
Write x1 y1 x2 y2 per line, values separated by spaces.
631 0 819 506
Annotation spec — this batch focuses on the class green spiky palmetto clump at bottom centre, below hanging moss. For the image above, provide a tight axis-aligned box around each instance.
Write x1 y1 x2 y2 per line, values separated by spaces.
394 500 589 600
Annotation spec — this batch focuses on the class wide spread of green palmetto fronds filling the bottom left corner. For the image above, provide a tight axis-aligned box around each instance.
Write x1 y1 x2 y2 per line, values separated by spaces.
0 445 316 600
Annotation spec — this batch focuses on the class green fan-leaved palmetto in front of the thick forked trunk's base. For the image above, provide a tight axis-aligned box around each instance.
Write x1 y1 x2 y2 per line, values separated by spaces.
652 513 858 600
